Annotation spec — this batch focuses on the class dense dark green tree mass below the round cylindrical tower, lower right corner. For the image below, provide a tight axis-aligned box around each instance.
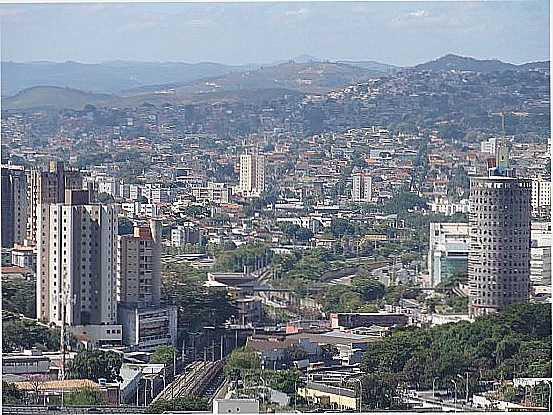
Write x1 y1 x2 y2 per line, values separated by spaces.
363 304 551 408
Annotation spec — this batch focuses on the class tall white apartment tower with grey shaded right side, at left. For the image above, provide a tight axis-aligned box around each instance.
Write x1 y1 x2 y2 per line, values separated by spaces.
37 190 117 326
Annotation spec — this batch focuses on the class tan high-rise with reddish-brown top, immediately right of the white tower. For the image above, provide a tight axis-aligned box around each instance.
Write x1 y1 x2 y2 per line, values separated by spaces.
117 219 161 307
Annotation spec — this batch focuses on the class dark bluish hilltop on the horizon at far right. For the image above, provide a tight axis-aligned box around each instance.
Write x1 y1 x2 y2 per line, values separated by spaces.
413 53 549 72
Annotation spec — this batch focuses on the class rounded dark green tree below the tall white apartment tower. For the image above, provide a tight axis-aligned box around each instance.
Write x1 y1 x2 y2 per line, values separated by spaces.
69 350 123 382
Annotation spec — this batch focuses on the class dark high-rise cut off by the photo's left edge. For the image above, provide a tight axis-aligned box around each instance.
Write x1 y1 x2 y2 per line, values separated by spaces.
1 166 28 248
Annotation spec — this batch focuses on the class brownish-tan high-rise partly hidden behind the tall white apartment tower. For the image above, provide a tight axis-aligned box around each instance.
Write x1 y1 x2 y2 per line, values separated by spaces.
27 161 83 242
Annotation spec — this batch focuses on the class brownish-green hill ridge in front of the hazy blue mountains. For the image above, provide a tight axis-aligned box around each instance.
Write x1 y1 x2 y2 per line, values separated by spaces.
2 61 382 110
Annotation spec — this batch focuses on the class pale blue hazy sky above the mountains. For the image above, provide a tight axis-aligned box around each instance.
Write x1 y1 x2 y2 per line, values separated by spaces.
0 0 549 65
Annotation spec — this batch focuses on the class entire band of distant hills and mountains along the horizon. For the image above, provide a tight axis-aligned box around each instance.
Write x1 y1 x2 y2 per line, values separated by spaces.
1 54 549 110
